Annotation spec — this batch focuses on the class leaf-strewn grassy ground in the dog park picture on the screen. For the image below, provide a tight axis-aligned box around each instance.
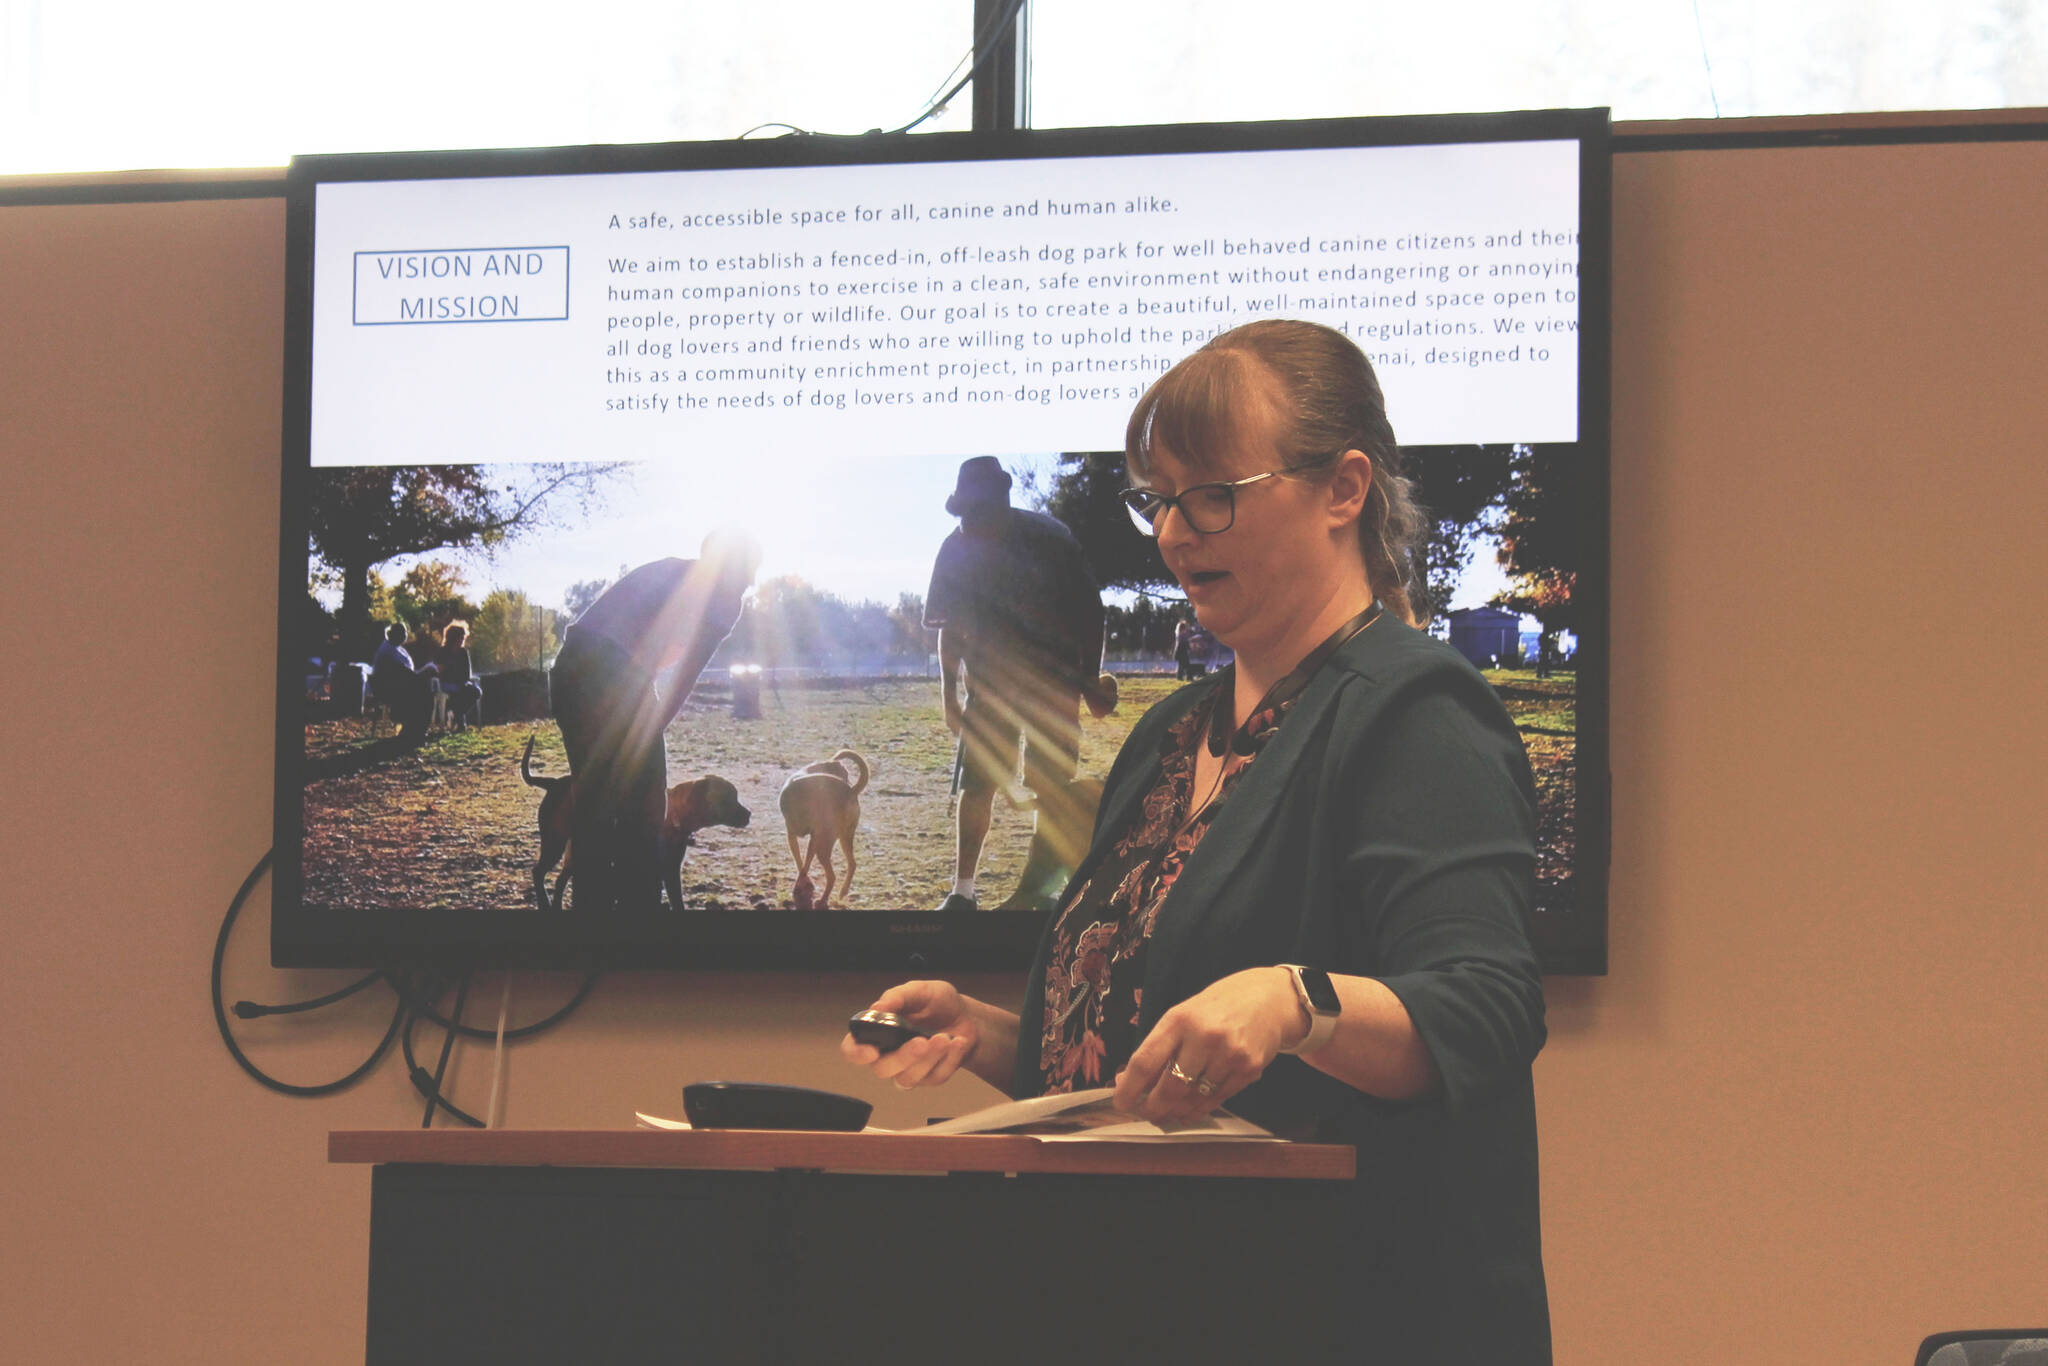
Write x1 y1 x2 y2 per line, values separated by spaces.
305 670 1575 913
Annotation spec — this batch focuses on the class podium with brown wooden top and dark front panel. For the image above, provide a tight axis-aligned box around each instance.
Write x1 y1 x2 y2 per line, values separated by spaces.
328 1128 1354 1366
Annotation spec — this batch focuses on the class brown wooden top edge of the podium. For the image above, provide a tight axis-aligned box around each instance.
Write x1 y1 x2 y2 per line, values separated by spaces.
328 1128 1358 1182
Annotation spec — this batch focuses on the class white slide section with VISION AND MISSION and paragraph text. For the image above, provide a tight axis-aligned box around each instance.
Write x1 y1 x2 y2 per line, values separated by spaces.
311 141 1579 465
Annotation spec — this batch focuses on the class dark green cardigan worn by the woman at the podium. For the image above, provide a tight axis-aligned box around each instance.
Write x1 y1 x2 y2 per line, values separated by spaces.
1014 618 1550 1366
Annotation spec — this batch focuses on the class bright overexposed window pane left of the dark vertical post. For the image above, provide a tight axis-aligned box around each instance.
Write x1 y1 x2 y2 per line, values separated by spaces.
0 0 973 174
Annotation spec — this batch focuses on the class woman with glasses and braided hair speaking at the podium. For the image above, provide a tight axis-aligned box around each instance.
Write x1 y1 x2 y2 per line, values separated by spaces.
842 322 1550 1366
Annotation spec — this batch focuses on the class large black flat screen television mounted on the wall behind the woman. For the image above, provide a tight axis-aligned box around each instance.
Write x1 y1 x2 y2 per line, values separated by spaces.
272 111 1608 973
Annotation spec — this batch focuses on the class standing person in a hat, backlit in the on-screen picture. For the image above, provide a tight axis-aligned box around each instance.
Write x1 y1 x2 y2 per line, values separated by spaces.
924 455 1116 911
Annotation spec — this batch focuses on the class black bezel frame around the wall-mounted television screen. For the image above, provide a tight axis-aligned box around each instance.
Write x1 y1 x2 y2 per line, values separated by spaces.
270 109 1612 975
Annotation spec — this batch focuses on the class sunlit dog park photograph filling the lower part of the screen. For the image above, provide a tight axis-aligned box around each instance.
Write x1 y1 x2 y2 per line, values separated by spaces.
295 446 1579 958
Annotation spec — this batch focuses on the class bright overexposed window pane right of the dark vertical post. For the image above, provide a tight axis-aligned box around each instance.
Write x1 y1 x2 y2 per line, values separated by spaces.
1032 0 2048 127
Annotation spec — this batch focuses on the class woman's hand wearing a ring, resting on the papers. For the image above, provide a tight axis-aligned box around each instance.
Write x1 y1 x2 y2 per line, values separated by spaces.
1116 967 1303 1122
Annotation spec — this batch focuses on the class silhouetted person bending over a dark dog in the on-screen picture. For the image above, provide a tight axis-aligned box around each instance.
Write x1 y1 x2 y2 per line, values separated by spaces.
549 532 760 911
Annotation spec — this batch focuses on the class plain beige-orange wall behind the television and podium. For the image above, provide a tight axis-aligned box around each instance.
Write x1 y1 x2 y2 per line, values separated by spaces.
0 131 2048 1366
